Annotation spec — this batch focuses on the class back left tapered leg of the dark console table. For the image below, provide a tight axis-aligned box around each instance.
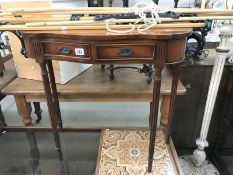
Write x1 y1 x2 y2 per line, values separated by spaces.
48 61 63 130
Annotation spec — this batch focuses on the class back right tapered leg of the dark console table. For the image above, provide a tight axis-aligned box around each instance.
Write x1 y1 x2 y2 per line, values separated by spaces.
166 64 180 144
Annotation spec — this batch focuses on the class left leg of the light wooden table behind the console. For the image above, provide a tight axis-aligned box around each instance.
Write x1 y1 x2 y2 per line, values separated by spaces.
15 95 32 126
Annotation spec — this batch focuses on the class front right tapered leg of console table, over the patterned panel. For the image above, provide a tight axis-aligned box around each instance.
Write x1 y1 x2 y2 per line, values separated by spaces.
148 68 162 173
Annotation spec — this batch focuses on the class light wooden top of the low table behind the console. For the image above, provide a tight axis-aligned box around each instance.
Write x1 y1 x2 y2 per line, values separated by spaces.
2 65 186 100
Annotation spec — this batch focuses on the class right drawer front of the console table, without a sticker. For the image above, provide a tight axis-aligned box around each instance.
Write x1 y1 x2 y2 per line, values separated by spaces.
96 43 155 60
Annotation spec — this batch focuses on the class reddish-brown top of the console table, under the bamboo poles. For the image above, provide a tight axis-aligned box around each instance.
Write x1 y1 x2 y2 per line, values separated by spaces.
22 28 193 40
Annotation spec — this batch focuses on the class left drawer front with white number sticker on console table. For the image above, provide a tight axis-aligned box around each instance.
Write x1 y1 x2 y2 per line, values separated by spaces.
42 41 91 59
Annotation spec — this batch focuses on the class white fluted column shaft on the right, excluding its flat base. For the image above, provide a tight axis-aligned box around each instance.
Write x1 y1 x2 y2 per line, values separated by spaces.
193 26 233 166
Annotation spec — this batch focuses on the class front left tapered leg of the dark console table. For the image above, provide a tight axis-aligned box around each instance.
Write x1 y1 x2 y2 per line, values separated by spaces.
40 62 61 149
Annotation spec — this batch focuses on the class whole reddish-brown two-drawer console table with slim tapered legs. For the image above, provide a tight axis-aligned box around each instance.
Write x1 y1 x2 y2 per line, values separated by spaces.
23 28 192 172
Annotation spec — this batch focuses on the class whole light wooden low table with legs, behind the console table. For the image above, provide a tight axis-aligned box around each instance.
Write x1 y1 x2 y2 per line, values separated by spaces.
2 65 186 126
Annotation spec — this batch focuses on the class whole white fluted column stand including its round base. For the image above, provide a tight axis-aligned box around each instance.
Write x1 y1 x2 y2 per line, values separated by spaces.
180 26 233 175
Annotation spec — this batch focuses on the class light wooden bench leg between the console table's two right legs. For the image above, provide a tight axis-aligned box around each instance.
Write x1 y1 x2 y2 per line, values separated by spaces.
160 95 171 126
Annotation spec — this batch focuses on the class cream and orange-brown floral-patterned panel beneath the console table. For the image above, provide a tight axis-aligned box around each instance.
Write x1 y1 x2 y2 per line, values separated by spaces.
96 130 176 175
